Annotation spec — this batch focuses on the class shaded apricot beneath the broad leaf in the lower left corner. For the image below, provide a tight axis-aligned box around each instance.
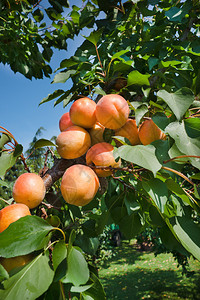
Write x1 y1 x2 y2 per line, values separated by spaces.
0 254 33 272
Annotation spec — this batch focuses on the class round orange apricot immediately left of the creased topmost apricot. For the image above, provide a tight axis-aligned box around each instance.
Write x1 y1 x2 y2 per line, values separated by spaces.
69 97 96 128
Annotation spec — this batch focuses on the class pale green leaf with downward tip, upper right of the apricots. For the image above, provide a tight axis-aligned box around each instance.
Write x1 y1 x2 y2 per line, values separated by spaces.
157 88 194 121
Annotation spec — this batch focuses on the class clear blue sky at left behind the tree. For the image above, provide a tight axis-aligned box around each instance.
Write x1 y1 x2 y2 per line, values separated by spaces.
0 0 89 150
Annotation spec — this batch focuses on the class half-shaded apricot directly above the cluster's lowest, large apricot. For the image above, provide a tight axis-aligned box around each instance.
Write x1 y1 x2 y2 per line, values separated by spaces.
86 142 120 177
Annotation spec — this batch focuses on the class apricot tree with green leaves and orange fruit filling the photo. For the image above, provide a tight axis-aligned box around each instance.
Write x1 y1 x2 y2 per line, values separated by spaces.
0 0 200 300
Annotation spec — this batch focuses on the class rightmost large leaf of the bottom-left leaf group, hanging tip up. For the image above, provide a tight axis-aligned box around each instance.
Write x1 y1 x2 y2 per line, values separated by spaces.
61 246 90 286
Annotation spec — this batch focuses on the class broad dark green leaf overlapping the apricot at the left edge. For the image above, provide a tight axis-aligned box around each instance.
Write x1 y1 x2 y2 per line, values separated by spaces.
0 216 54 257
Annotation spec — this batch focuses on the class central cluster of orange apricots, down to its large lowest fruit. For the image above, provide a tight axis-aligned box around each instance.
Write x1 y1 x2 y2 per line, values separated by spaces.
56 94 164 206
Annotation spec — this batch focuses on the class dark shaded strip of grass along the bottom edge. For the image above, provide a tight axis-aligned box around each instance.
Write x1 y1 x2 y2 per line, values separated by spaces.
101 269 200 300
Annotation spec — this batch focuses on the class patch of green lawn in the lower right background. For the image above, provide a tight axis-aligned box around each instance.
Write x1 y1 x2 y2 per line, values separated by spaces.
99 241 200 300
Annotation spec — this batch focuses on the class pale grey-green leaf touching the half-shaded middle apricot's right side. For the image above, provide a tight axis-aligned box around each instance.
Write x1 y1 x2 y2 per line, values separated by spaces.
114 145 162 176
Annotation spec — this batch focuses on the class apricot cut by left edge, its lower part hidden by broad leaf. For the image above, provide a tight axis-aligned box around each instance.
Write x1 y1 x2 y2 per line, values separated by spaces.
0 203 31 232
